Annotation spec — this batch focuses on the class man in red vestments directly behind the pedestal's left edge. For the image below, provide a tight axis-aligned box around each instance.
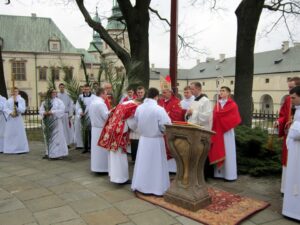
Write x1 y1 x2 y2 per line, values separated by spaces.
158 89 184 173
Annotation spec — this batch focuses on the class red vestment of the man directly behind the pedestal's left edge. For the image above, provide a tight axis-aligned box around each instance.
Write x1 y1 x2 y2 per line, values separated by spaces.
158 95 184 160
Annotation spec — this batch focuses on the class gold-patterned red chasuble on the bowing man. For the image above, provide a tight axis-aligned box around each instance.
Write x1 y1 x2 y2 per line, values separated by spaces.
98 102 138 153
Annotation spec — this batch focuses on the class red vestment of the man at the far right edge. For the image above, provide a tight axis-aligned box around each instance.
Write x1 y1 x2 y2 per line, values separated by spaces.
277 96 292 166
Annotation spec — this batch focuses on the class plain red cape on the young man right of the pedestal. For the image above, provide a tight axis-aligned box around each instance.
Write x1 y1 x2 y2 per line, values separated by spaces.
208 98 241 167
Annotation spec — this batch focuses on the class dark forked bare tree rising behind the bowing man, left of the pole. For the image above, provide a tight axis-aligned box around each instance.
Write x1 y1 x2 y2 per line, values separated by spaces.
76 0 151 87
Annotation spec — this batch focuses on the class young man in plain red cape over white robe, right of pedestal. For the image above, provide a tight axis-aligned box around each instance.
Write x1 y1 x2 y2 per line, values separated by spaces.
208 86 241 180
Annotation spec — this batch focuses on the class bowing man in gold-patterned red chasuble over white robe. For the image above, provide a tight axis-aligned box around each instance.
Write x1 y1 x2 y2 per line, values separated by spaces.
98 100 139 184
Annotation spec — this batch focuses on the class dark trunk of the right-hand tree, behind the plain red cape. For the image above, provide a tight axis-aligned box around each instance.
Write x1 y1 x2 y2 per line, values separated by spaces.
234 0 265 126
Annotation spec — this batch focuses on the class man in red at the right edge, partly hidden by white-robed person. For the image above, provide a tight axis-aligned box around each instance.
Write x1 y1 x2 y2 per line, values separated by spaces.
275 77 300 193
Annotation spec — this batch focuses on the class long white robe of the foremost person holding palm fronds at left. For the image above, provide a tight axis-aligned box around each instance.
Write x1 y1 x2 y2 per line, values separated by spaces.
39 98 69 159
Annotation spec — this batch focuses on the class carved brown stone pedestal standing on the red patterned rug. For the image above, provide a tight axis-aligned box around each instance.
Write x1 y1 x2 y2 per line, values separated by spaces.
164 125 213 211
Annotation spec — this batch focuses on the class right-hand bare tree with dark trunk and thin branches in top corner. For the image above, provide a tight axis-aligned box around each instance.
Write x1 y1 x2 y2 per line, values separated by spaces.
234 0 300 126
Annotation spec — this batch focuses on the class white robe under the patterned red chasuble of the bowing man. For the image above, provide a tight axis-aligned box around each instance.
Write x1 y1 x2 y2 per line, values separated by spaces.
108 100 136 183
